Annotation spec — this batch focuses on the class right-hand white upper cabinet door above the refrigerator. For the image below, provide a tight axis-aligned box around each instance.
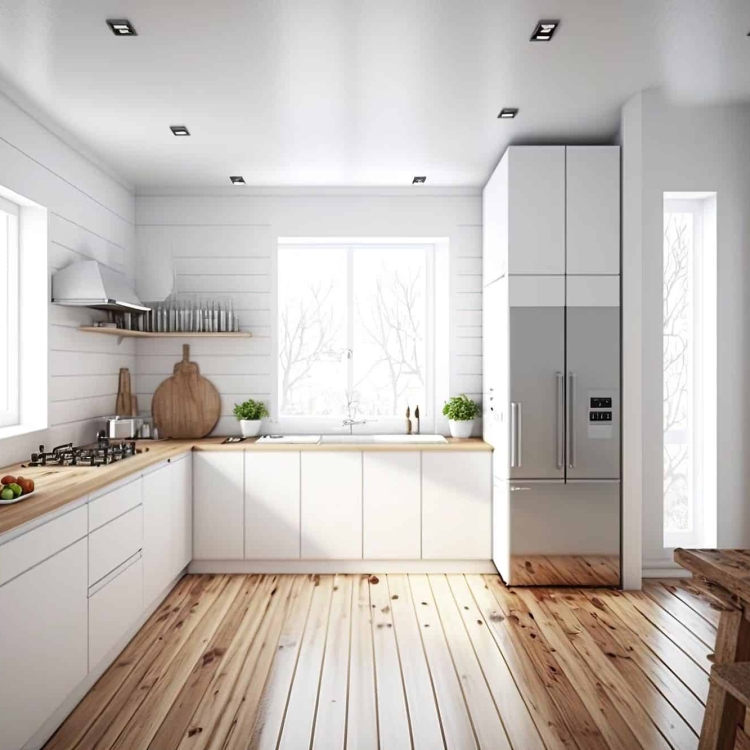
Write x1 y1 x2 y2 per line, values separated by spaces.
566 146 620 275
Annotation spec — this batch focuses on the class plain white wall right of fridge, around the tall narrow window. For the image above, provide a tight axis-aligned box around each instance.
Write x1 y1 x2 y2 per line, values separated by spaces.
622 90 750 575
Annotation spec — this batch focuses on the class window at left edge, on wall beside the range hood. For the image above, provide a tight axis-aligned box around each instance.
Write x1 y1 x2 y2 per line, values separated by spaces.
0 198 20 427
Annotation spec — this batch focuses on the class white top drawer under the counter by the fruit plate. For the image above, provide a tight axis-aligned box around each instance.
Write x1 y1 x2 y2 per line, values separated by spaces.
0 506 87 586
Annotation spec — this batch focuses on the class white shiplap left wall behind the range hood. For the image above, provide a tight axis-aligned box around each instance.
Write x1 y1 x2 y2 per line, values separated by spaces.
0 88 135 466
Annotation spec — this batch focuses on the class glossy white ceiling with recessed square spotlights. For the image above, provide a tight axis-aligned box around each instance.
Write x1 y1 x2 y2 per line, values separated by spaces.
0 0 750 189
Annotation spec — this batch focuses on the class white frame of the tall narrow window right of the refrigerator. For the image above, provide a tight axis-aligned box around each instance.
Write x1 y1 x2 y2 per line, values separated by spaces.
662 193 718 548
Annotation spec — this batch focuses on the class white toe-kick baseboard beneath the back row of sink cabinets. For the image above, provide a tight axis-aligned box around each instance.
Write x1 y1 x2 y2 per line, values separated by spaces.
188 560 497 574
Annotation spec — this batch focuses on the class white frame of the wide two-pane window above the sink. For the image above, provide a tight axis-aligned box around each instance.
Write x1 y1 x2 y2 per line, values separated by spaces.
270 237 440 434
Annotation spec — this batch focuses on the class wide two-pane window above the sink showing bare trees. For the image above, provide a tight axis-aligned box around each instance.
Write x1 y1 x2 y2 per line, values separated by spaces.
275 240 435 431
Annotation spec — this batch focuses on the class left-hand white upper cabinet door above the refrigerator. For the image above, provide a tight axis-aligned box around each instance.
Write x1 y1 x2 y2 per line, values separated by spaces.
507 146 565 275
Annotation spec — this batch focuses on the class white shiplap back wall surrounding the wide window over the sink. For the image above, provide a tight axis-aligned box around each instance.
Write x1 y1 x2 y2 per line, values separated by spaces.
136 189 482 434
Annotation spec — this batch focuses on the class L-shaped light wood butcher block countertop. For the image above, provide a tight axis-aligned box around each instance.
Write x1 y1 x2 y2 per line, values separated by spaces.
0 437 492 541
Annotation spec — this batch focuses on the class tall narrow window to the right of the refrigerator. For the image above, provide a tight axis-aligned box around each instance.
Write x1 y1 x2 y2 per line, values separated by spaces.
662 193 717 547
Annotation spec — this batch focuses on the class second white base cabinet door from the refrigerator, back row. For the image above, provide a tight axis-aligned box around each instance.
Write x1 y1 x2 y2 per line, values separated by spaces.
362 451 422 560
